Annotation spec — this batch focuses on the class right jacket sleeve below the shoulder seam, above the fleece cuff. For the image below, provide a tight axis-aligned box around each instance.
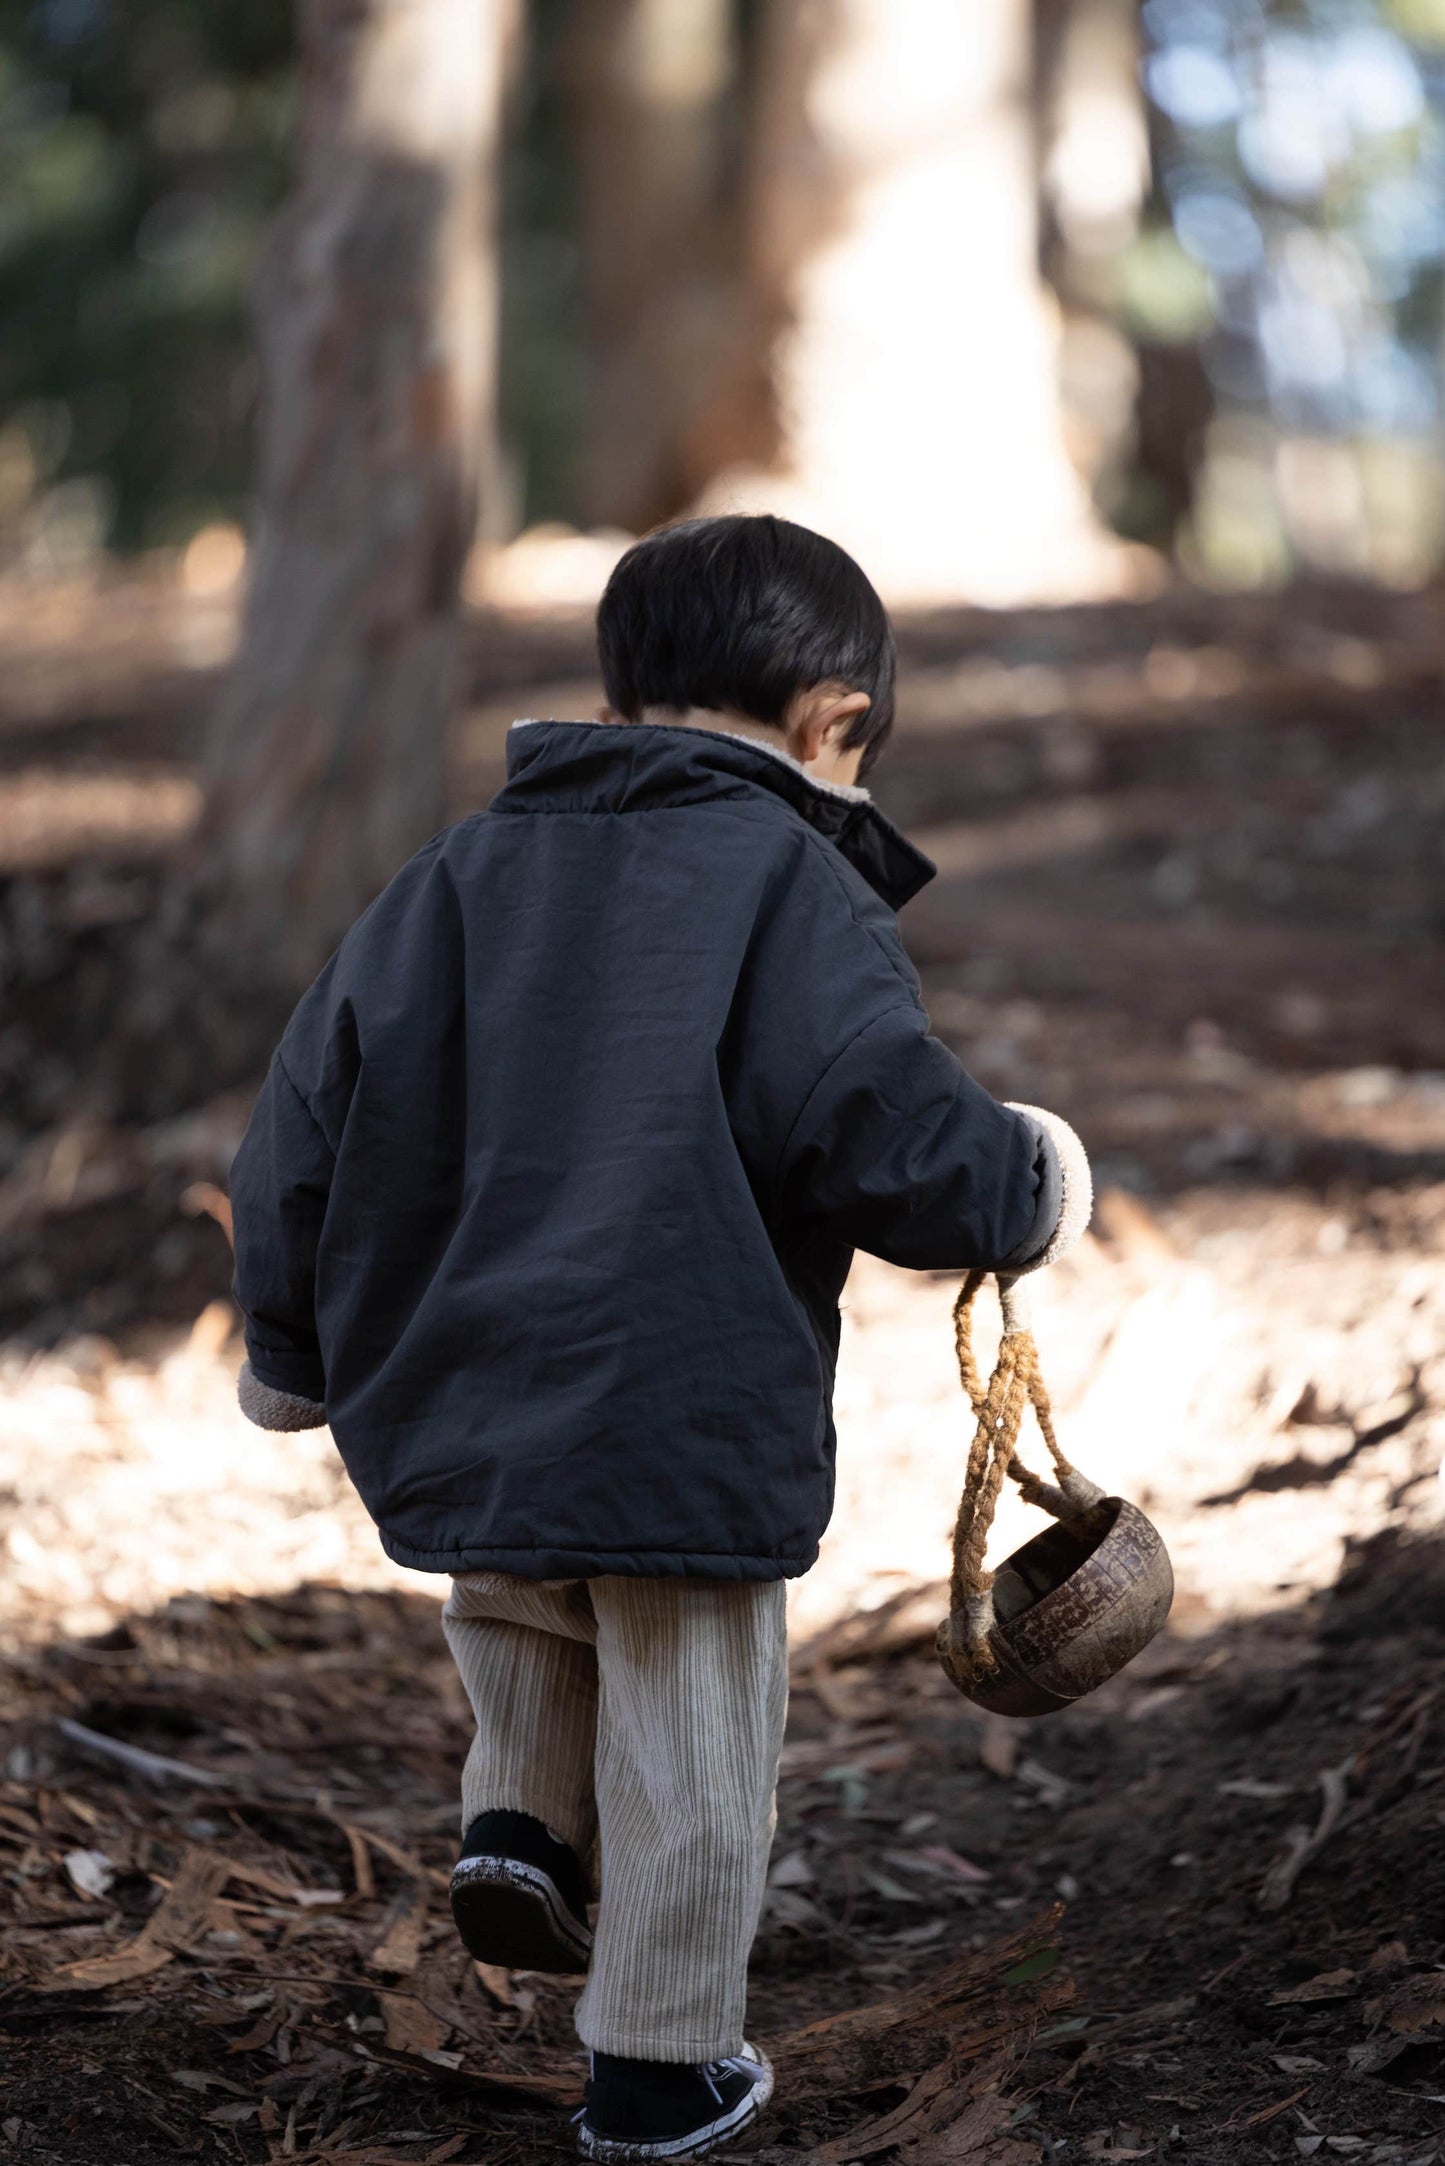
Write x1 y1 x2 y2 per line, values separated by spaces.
780 999 1059 1271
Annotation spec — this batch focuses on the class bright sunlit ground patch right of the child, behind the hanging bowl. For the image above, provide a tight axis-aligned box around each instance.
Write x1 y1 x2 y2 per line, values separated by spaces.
795 1200 1445 1631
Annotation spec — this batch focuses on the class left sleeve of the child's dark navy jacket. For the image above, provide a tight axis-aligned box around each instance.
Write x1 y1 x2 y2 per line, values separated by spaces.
232 1053 336 1427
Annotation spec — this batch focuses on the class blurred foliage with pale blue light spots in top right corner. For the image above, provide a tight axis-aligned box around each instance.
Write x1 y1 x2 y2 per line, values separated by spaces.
1116 0 1445 585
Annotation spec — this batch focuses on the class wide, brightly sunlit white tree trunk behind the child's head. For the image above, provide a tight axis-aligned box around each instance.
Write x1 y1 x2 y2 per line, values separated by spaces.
706 0 1116 602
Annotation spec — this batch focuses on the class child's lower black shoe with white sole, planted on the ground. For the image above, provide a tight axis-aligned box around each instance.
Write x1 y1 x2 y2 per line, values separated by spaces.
576 2045 773 2166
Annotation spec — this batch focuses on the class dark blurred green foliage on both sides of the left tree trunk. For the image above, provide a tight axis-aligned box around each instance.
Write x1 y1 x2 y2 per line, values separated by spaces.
0 0 585 570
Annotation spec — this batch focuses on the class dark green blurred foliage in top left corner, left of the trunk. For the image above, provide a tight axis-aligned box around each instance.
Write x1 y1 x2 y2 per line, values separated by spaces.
0 0 295 563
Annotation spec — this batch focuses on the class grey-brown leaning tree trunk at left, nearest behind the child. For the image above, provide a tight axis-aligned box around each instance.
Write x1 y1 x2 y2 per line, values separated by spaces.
199 0 507 983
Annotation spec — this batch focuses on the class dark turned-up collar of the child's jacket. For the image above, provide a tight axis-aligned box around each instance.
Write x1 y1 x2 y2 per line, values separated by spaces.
494 721 936 910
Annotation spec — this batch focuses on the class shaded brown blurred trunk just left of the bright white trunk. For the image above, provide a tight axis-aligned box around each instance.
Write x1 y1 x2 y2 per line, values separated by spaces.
568 0 750 531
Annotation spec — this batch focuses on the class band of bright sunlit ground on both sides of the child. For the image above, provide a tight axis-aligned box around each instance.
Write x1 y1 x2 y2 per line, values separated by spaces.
0 1198 1445 1640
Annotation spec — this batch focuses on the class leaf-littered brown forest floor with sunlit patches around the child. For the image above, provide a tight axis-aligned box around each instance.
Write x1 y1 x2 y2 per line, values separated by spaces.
0 583 1445 2166
